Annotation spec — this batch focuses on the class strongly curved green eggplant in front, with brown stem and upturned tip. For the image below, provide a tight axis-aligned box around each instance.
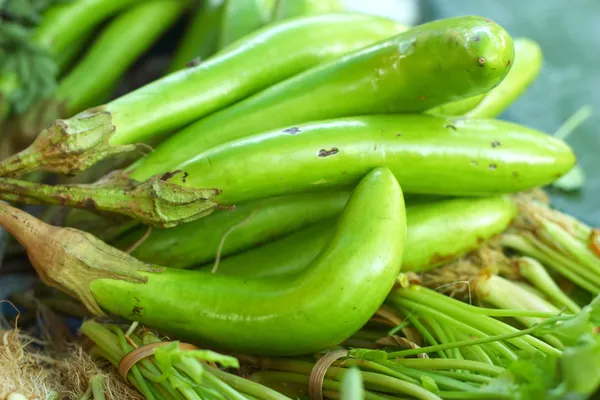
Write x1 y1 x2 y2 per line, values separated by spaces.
0 168 406 355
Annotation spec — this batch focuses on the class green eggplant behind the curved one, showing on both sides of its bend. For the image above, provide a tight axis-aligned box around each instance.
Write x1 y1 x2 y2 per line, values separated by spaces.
202 196 516 278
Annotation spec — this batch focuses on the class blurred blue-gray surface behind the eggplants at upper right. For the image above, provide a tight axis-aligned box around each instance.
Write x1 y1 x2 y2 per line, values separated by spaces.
427 0 600 226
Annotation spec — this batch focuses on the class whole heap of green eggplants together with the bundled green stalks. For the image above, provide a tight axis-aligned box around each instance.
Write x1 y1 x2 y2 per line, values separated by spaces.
0 0 600 400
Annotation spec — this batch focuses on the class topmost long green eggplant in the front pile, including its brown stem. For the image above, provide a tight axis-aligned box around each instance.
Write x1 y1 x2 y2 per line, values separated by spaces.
0 14 403 175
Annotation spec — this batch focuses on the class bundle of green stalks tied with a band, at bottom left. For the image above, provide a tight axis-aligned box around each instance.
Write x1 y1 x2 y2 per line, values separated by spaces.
80 321 288 400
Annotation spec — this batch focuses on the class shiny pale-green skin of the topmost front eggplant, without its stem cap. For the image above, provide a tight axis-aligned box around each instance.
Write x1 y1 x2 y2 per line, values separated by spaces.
103 14 403 145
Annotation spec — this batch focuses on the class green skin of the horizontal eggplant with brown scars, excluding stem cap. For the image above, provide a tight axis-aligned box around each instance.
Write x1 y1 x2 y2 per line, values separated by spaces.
161 115 575 204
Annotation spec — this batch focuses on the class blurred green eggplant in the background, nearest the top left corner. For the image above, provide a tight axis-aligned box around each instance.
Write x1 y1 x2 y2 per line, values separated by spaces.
34 0 145 70
